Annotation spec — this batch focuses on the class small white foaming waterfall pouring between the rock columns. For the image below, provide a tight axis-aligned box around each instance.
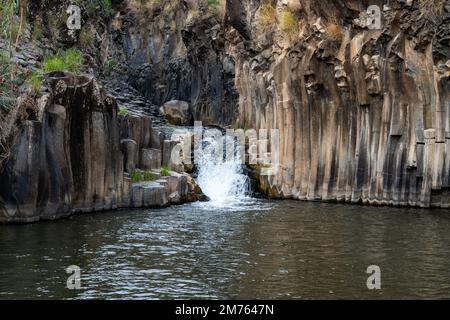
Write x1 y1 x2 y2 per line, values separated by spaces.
196 136 250 205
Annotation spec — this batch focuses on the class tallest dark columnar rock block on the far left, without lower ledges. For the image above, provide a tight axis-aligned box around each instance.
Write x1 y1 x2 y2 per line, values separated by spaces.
0 73 123 222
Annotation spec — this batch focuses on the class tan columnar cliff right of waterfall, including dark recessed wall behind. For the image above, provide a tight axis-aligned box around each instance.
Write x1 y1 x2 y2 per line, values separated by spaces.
113 0 450 207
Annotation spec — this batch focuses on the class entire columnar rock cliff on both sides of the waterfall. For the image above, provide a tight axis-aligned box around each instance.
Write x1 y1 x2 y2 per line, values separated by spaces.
0 0 450 221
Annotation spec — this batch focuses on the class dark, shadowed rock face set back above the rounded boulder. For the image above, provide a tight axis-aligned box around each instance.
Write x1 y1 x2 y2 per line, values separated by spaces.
108 0 238 126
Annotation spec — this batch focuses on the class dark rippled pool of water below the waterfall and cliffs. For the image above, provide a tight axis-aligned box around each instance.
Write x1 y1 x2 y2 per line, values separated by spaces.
0 200 450 299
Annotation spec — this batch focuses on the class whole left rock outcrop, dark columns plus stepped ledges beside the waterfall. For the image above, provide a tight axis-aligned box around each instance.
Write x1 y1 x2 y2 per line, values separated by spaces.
0 73 204 222
